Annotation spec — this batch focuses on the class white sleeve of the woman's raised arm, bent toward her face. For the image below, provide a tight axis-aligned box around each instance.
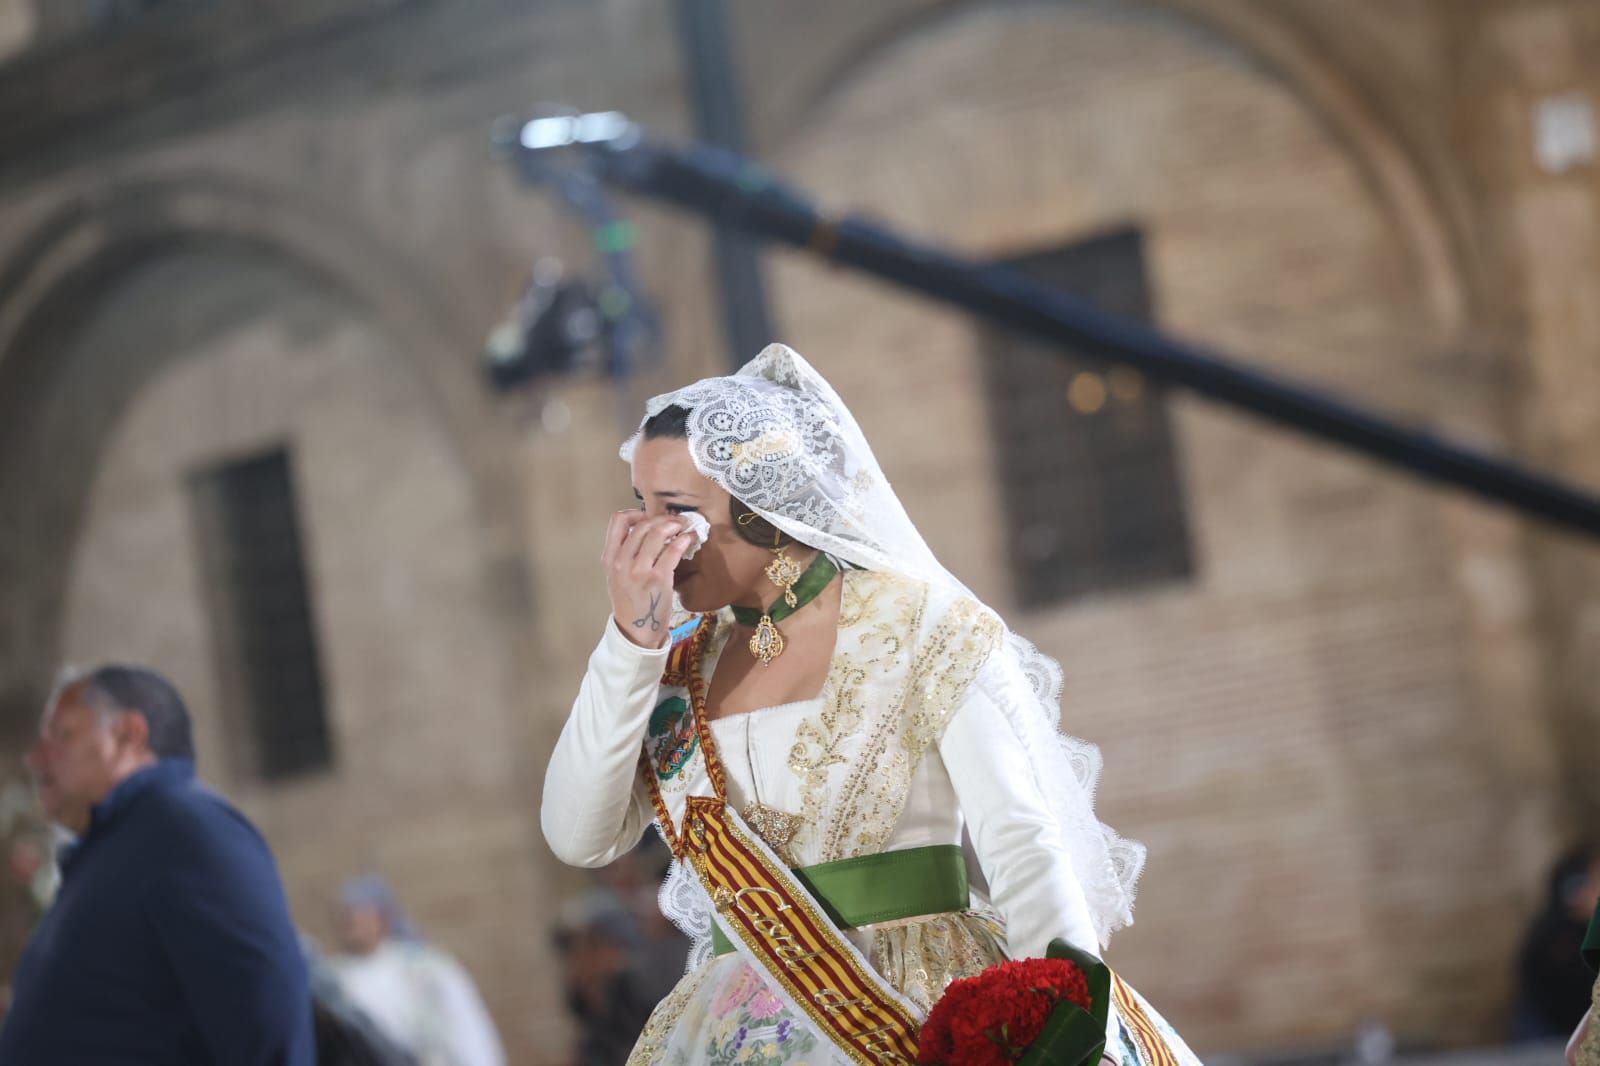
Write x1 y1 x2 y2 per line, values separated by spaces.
539 619 669 866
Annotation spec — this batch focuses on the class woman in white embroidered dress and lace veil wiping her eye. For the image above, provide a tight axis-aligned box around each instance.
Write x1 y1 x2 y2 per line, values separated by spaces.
542 344 1197 1066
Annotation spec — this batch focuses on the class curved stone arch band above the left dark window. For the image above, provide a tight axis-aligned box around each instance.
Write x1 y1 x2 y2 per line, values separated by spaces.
0 173 533 725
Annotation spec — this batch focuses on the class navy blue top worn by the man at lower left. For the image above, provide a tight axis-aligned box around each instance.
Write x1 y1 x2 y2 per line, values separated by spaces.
0 759 314 1066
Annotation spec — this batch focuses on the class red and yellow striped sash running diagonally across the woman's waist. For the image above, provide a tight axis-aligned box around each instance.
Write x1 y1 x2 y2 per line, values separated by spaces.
683 797 920 1066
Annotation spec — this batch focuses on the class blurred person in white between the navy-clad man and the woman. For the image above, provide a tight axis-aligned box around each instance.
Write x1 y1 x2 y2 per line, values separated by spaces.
330 876 506 1066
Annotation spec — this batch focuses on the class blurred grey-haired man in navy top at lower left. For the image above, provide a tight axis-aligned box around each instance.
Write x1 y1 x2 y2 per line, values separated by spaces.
0 666 315 1066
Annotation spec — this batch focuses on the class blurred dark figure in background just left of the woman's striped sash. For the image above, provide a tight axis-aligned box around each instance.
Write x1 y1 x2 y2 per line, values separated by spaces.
555 834 690 1066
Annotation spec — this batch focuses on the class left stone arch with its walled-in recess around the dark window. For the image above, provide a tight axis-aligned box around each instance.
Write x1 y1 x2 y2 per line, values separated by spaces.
0 173 557 1024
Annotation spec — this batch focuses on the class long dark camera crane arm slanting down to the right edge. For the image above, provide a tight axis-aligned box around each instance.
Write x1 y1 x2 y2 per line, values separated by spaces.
502 126 1600 539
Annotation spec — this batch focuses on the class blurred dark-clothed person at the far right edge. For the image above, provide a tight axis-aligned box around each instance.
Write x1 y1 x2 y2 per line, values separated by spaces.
1512 848 1600 1040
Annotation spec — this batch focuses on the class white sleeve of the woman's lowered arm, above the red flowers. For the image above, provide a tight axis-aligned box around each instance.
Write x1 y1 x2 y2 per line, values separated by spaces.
939 656 1099 959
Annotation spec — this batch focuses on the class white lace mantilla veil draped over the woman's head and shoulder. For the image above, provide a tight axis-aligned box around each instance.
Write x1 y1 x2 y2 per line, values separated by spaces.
622 344 1144 970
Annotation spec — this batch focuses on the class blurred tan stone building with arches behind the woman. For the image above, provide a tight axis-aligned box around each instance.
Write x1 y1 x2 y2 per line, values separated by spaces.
0 0 1600 1063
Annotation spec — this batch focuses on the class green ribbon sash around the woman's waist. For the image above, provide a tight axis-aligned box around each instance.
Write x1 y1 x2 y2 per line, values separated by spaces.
710 844 971 956
